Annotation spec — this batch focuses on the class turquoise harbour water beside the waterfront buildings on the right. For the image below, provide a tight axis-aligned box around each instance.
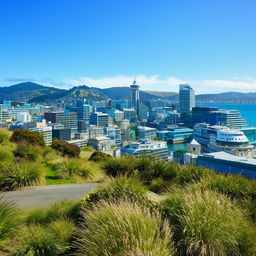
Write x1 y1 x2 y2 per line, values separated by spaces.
168 103 256 152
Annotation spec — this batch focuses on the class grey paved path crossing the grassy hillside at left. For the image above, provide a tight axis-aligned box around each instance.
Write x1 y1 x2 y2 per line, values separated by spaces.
3 183 98 208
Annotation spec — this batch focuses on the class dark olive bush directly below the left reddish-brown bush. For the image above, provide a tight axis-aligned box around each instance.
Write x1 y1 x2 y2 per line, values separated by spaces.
14 144 43 161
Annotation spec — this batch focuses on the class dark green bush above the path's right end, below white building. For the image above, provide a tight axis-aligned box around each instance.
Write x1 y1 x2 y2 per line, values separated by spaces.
103 157 136 177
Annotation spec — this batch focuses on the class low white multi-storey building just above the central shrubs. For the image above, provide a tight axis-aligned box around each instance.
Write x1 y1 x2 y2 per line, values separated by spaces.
121 140 169 161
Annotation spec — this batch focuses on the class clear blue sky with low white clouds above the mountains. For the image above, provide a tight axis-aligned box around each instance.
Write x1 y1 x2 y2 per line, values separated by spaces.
0 0 256 93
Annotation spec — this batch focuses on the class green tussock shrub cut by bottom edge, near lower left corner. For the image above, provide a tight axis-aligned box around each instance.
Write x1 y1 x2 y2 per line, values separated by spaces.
13 225 67 256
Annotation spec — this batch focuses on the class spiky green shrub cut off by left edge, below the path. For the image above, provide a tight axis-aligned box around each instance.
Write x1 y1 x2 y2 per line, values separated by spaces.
0 197 19 247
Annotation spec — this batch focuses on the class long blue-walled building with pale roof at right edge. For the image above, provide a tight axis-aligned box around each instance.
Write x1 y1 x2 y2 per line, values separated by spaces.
196 151 256 179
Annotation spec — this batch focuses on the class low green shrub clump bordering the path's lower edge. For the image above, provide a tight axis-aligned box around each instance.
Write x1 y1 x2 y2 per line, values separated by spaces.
24 200 80 224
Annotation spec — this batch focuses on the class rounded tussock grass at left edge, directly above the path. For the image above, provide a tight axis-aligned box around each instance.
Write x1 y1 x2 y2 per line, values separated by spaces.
0 162 45 190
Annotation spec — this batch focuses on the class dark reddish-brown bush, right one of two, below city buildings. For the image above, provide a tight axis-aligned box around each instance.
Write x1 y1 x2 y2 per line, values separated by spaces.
52 139 81 157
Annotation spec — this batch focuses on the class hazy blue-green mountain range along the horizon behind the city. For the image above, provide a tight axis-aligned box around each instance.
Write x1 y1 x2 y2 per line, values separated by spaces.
0 82 256 104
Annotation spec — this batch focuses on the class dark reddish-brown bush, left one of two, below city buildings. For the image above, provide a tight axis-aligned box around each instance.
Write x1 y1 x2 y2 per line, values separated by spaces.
10 129 45 146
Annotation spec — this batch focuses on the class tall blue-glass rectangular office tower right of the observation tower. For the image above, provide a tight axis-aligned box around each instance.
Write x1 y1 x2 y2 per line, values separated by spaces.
179 84 195 113
